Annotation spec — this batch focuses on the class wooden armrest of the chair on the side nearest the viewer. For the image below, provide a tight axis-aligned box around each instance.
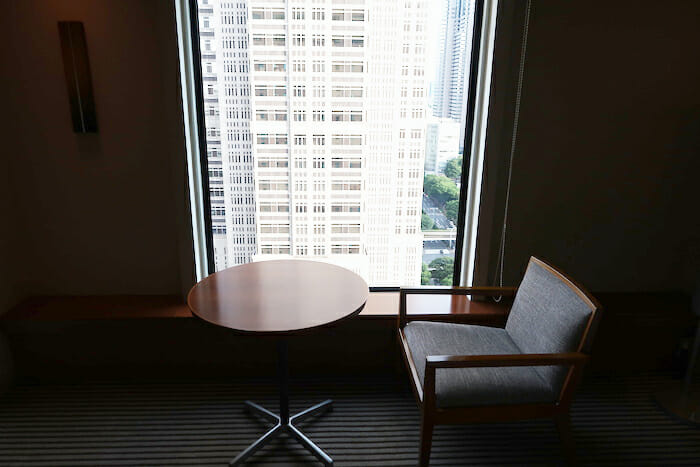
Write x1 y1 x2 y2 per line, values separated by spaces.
425 352 588 370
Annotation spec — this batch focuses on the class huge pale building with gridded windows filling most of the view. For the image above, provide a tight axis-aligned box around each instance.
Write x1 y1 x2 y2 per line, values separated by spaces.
199 0 429 285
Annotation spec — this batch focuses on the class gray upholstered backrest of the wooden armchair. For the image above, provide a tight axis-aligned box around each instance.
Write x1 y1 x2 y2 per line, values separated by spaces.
506 256 600 393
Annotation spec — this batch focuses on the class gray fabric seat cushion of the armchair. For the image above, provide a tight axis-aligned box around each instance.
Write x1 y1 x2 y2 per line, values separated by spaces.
404 321 556 408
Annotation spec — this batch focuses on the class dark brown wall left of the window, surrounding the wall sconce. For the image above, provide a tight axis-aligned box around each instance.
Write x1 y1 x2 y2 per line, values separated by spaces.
0 0 188 304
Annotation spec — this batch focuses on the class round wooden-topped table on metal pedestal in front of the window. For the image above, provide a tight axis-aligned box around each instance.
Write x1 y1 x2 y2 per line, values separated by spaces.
187 260 369 465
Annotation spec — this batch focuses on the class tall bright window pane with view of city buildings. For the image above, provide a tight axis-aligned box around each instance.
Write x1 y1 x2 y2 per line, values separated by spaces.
192 0 478 287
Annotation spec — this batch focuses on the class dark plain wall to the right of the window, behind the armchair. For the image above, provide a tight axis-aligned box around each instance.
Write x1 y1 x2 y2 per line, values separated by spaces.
480 0 700 291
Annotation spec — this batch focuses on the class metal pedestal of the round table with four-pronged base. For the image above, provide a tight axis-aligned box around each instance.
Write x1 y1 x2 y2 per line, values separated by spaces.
229 339 333 466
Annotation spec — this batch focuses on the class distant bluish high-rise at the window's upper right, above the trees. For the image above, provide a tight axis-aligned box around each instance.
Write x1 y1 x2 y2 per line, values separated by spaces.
432 0 474 133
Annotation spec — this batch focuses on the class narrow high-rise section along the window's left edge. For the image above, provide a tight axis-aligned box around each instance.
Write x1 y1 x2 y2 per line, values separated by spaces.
199 0 257 270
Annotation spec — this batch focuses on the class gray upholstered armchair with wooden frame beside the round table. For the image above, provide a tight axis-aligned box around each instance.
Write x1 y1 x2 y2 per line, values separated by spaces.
399 257 601 466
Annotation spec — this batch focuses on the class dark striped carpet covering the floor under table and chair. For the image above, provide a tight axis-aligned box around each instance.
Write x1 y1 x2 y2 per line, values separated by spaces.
0 375 700 466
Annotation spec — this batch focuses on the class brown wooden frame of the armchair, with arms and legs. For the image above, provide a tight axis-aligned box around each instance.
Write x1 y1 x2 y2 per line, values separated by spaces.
398 257 602 466
